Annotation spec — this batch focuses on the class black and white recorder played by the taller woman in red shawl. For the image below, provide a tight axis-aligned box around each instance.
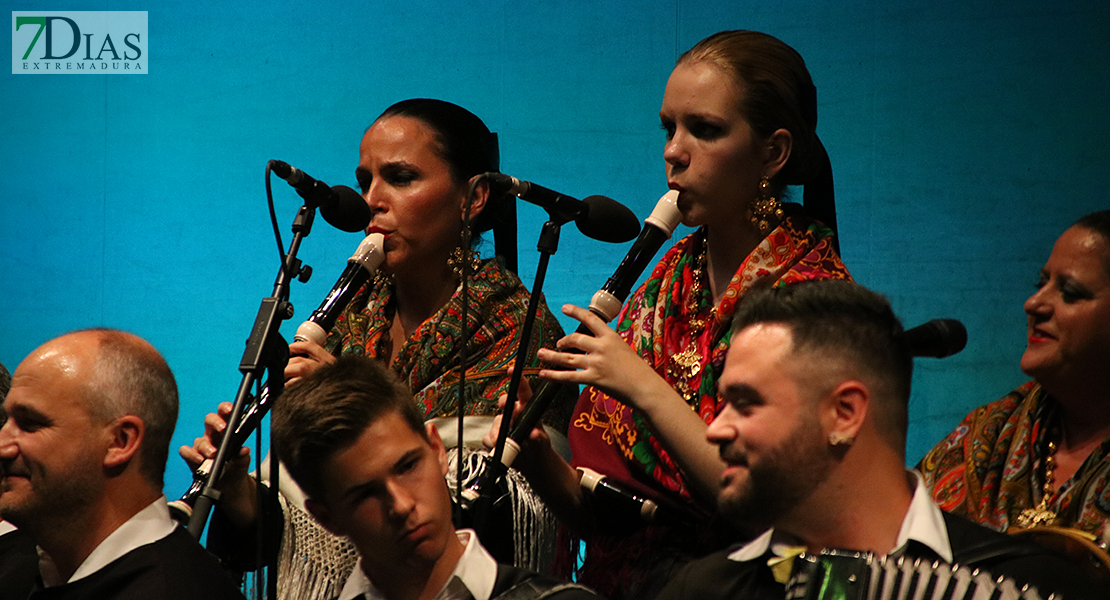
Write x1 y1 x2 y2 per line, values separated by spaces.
502 190 683 467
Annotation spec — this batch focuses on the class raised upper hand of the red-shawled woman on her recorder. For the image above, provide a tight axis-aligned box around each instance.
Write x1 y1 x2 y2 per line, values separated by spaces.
538 304 670 409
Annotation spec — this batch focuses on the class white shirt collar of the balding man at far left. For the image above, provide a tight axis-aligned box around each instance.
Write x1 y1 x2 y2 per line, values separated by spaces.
39 496 176 588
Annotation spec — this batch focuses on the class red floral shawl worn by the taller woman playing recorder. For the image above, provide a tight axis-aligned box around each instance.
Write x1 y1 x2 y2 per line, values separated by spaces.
568 207 849 500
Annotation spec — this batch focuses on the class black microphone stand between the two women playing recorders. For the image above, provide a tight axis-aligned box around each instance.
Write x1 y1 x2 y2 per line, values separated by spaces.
471 216 568 539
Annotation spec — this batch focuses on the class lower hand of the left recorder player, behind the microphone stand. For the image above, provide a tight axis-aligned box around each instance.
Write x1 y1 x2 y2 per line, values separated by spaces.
178 403 258 527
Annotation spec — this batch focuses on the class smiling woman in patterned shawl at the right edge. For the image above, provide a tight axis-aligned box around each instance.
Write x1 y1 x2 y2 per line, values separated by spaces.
918 211 1110 542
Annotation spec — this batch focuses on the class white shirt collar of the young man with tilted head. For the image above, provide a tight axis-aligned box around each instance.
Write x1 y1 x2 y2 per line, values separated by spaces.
339 529 497 600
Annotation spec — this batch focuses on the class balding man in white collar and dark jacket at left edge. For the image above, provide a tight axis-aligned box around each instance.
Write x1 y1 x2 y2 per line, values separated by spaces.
0 329 242 600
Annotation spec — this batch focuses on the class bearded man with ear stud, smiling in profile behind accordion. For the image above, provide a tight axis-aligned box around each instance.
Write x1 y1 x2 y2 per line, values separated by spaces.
659 281 1104 600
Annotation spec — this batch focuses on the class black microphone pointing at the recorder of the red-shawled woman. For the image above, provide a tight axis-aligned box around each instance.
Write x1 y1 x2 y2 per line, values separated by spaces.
483 172 639 243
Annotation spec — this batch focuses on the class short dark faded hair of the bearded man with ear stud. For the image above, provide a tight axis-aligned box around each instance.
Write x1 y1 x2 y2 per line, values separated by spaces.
733 279 914 451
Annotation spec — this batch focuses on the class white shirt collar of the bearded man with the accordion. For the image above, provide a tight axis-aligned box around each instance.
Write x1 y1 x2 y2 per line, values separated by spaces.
728 471 952 562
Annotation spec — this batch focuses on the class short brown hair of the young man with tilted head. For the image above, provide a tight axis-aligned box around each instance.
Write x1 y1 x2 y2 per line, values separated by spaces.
272 355 427 499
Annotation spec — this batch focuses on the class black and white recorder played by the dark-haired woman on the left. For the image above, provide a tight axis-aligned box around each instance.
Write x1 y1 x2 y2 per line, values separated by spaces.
169 233 385 525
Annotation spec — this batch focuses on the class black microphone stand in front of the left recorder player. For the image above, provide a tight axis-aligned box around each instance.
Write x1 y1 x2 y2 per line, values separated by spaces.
189 204 315 552
